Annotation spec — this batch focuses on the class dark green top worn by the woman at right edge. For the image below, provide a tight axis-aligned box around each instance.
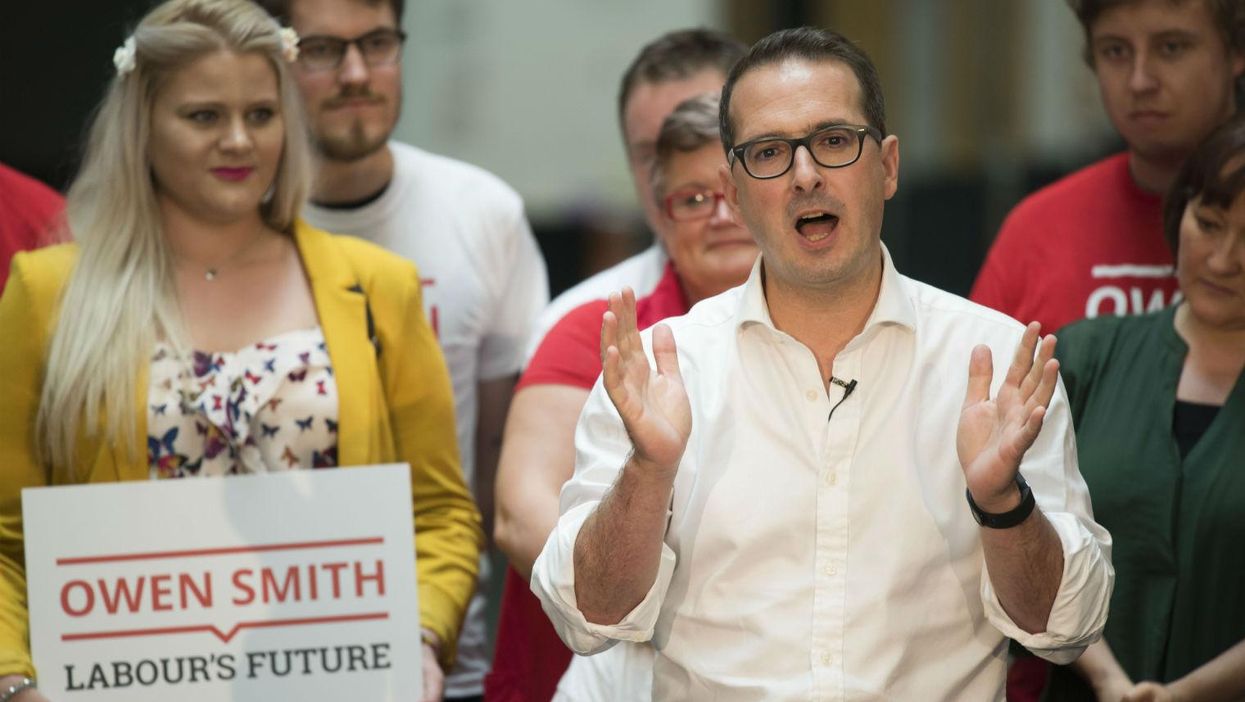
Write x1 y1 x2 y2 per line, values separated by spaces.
1048 307 1245 700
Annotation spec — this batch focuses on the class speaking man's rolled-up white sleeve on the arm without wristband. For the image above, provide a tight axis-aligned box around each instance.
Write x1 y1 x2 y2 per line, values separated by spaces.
532 380 676 655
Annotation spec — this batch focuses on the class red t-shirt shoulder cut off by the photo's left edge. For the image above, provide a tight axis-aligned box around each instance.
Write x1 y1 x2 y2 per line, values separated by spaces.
0 163 65 291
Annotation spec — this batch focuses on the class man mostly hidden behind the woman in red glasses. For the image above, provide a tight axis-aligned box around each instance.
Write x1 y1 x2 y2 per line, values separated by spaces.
527 29 746 357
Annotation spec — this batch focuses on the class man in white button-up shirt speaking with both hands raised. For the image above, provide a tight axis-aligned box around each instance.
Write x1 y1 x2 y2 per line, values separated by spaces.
532 29 1114 700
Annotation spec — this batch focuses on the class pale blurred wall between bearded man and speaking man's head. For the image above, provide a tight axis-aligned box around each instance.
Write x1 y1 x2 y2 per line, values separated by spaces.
396 0 723 219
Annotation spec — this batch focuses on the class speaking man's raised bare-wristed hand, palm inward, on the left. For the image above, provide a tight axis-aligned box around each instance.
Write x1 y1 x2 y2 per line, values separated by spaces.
601 288 692 472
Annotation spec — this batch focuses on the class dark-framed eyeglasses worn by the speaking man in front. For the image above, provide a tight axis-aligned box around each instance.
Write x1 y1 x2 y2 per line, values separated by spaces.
731 124 881 180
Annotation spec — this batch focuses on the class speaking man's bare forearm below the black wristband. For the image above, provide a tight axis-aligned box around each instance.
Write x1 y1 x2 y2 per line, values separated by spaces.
981 509 1063 634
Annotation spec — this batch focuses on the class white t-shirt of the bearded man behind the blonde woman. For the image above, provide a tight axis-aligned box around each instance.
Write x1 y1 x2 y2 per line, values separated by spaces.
303 142 549 697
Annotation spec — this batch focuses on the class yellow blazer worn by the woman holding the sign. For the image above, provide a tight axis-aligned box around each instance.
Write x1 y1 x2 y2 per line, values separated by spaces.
0 222 482 676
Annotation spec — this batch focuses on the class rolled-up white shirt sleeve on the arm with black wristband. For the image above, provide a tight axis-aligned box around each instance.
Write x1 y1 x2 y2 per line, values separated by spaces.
981 382 1116 665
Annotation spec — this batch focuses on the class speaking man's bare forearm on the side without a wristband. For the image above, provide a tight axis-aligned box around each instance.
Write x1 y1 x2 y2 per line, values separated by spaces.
574 456 675 625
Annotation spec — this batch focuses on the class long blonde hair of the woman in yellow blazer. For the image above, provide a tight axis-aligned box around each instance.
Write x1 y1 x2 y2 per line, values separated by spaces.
36 0 311 472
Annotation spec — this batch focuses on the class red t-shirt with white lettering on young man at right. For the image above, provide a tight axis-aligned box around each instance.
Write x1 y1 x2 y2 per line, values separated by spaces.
970 153 1178 332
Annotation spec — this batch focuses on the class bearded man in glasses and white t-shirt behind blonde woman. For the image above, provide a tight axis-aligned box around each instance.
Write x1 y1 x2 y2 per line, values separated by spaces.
264 0 549 700
